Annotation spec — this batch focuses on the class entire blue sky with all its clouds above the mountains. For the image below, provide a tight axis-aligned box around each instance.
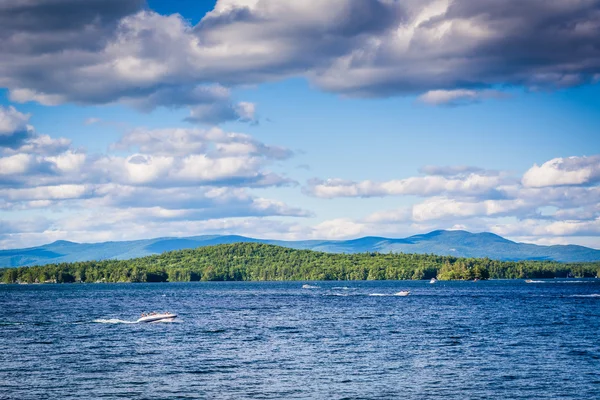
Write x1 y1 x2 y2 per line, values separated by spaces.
0 0 600 249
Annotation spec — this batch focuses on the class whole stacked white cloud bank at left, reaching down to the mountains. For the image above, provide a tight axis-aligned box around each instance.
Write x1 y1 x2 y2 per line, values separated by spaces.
0 109 312 245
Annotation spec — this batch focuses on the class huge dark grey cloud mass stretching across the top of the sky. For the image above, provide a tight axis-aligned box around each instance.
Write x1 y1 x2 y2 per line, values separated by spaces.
0 0 600 108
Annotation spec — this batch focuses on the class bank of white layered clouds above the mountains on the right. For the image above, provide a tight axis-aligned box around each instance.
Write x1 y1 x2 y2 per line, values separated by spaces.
304 156 600 247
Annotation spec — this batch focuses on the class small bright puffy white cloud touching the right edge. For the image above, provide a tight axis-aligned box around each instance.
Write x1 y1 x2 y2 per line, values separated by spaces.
523 155 600 188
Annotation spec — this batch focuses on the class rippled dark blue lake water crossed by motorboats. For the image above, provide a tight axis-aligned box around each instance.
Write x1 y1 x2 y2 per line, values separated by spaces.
0 279 600 400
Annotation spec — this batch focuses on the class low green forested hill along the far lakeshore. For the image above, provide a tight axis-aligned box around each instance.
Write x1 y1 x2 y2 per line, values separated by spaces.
0 243 600 283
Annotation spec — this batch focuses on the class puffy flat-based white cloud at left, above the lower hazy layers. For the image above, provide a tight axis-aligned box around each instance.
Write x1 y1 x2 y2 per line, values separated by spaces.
0 122 295 187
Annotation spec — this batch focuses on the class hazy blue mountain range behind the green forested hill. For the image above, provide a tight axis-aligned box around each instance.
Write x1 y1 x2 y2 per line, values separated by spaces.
0 230 600 267
